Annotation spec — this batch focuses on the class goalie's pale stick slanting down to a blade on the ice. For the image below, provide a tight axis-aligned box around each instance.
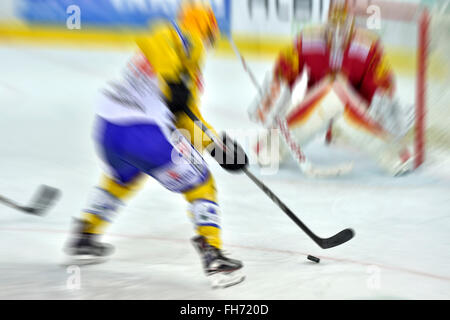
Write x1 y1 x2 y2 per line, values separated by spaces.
228 37 353 178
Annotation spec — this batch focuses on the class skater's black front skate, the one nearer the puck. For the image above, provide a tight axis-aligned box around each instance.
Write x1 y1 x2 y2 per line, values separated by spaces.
192 236 245 288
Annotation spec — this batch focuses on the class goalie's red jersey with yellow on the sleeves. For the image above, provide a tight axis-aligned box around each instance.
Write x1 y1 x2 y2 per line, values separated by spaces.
274 26 394 111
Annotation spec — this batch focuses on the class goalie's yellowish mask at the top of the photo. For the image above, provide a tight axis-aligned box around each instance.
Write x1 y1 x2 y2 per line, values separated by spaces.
327 0 355 70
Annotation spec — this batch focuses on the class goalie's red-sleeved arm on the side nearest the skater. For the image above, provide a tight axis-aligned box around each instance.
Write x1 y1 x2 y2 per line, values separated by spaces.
249 36 303 127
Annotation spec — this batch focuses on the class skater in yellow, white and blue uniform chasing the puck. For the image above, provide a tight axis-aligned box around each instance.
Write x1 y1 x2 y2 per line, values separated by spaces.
65 1 248 287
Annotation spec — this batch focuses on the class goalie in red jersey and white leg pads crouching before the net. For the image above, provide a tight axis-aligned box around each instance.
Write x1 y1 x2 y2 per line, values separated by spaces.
249 0 414 176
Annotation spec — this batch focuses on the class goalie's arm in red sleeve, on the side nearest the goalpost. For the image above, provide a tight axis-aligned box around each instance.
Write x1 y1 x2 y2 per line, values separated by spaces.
359 41 414 137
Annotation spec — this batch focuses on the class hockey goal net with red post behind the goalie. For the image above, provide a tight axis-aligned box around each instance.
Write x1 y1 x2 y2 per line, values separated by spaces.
355 0 450 167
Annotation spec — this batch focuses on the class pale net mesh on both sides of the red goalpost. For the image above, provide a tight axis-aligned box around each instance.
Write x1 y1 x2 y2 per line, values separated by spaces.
357 0 450 160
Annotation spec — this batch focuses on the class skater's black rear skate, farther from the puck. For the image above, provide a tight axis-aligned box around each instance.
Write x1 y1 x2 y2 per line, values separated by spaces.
64 219 114 264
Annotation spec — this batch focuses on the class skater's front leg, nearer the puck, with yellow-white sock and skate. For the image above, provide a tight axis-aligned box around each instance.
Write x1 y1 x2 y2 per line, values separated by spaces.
149 131 244 286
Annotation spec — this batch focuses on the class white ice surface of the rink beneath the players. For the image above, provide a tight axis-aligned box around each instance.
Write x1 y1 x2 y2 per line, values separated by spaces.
0 45 450 299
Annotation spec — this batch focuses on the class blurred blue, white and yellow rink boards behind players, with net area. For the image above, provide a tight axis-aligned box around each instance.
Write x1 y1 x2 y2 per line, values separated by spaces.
0 0 450 147
